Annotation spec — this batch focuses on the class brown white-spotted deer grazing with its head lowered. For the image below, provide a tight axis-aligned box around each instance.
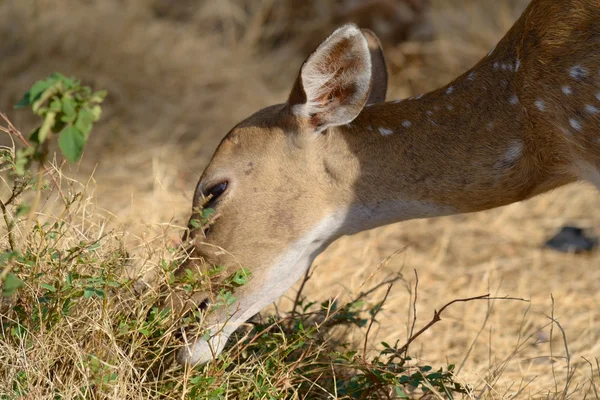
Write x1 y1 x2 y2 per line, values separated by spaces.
171 0 600 364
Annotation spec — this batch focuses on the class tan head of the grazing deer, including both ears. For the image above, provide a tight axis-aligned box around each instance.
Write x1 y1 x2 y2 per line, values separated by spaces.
172 24 387 364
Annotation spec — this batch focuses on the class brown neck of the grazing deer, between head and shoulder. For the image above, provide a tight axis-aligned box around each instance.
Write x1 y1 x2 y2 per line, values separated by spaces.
328 63 573 232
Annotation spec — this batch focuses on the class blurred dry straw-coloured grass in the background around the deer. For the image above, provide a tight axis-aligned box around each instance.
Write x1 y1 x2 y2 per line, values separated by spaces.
0 0 600 399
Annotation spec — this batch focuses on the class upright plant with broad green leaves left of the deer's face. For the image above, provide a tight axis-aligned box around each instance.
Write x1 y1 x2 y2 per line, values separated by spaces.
0 73 106 296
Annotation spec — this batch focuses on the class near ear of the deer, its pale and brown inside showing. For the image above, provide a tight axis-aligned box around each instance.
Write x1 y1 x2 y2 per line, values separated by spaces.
288 24 372 132
